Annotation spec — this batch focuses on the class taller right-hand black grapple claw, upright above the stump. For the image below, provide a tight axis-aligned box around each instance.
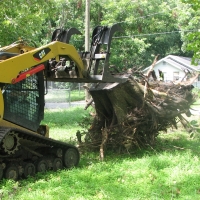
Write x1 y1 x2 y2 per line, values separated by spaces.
81 24 126 82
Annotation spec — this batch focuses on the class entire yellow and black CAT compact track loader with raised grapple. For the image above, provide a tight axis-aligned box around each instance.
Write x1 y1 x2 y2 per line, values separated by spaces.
0 24 126 180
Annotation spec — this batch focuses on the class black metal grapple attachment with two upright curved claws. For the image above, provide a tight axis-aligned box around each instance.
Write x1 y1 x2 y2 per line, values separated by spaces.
47 24 126 83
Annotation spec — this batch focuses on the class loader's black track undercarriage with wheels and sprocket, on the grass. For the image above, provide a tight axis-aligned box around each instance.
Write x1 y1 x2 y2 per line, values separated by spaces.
0 127 80 180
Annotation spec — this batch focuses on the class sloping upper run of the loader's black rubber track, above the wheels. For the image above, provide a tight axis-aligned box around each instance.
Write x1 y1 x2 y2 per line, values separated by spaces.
0 127 80 157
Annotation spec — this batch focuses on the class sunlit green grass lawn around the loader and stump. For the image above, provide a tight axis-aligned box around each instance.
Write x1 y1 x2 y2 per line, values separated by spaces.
0 108 200 200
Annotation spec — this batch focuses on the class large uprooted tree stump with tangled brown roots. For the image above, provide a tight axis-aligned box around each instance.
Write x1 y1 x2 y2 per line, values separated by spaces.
78 71 195 158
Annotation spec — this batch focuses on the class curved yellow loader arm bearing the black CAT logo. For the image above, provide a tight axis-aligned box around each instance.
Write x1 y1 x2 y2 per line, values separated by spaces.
0 41 85 83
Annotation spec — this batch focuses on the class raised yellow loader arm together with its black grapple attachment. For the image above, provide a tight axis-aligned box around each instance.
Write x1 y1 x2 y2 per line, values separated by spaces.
0 24 127 84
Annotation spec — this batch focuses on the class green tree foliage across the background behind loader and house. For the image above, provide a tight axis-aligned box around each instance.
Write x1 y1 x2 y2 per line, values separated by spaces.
0 0 200 67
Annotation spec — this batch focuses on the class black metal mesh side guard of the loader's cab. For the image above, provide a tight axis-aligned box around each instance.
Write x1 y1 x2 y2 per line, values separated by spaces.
3 72 44 131
